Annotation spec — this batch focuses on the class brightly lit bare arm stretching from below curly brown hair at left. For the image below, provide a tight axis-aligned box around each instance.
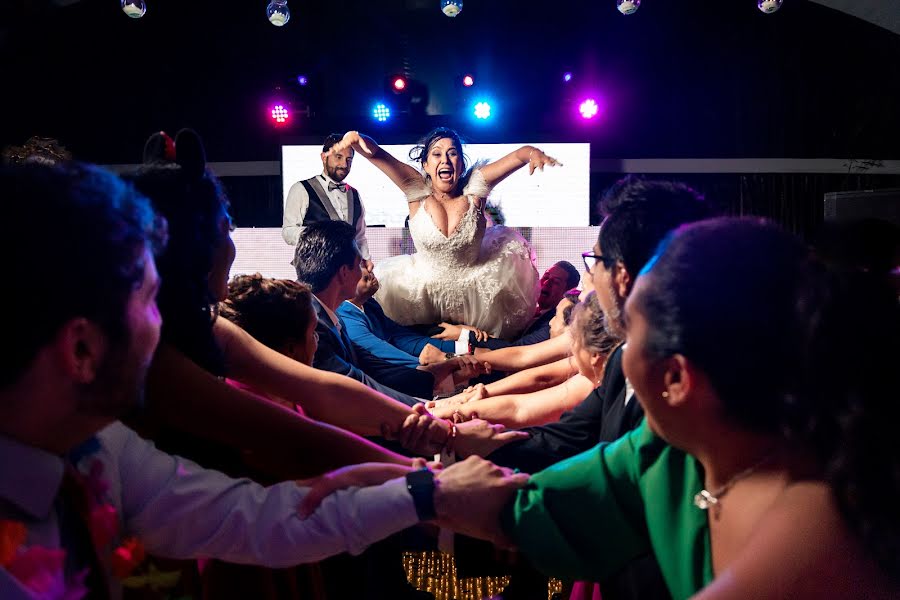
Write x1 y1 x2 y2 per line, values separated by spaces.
213 319 436 435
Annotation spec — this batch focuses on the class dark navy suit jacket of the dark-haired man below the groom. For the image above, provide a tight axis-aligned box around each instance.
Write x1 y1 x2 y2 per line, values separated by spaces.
313 296 434 406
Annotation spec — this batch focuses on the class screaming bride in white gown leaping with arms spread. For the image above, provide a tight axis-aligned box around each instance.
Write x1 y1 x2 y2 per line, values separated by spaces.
332 128 559 339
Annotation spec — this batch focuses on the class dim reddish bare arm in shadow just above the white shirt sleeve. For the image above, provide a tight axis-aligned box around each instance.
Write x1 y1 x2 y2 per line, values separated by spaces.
147 344 409 479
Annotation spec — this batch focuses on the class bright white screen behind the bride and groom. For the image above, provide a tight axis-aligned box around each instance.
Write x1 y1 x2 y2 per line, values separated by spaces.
281 142 591 227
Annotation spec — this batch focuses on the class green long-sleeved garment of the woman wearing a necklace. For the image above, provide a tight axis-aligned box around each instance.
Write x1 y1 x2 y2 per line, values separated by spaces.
501 420 712 598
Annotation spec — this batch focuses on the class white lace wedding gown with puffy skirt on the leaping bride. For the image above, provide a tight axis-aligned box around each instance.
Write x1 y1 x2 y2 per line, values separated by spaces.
375 170 538 339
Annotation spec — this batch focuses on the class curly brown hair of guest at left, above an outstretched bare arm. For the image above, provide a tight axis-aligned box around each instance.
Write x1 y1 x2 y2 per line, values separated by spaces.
219 273 312 350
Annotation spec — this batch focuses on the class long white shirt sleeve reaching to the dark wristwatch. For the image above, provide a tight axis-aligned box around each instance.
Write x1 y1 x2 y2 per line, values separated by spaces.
110 423 418 568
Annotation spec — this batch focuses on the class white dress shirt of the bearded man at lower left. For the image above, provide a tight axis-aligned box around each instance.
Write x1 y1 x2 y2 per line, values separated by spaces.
0 422 418 600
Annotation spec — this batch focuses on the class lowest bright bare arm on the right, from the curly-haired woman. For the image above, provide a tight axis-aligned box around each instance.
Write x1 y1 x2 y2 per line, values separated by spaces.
432 375 594 428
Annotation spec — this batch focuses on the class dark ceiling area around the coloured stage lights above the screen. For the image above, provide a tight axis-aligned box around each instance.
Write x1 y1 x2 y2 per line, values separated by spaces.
0 0 900 163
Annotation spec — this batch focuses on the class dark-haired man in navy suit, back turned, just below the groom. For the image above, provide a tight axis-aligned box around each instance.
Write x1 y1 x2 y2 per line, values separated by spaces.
293 221 434 406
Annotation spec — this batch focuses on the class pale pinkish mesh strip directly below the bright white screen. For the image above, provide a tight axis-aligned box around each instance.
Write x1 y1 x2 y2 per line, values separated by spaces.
231 226 599 279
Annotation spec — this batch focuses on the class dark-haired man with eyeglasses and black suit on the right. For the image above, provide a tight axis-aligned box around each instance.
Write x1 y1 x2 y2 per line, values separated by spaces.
478 177 712 600
